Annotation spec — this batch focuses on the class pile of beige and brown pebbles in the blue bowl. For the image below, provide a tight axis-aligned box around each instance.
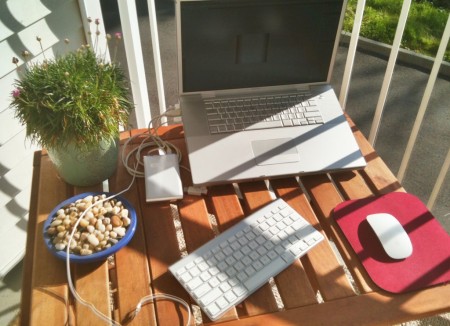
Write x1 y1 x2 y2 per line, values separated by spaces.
46 194 131 256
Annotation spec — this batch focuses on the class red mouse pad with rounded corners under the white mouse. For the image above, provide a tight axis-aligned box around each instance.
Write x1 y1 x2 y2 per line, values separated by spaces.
333 192 450 293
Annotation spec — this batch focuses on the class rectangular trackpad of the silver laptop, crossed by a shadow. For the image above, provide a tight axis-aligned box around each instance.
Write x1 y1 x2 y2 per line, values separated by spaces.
252 138 299 165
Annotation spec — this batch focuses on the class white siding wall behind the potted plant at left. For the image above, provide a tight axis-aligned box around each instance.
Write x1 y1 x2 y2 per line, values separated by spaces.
0 0 101 278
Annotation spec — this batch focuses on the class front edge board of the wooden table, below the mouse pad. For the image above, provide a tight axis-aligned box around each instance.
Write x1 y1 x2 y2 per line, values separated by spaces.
211 283 450 326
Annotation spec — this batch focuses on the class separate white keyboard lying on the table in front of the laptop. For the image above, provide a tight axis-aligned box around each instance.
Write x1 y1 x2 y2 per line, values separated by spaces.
169 199 324 320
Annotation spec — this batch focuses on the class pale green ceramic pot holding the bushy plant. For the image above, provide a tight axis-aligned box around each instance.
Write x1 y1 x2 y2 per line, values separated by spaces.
48 140 119 187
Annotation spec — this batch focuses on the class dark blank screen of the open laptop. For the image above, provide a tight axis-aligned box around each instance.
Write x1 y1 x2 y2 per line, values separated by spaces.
178 0 343 93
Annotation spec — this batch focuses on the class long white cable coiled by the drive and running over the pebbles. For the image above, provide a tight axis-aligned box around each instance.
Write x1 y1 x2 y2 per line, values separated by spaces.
62 108 191 325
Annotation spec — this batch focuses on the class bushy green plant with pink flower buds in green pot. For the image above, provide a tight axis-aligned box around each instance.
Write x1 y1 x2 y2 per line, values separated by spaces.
11 20 133 186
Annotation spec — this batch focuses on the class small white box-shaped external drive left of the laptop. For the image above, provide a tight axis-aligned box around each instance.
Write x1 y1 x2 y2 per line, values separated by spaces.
144 154 183 202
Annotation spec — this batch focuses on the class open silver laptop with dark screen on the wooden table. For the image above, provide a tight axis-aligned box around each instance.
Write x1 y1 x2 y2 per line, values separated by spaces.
176 0 366 185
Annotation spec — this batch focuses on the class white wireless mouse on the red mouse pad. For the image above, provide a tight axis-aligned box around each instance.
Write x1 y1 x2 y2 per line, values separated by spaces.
366 213 413 259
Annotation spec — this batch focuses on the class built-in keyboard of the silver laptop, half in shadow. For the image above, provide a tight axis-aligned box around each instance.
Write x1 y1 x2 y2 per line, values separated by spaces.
205 94 323 134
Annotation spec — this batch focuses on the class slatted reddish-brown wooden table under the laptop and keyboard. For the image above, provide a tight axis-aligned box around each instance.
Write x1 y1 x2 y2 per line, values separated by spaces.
21 121 450 326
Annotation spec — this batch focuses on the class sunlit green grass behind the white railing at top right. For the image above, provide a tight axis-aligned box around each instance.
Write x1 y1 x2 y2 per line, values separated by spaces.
344 0 450 61
